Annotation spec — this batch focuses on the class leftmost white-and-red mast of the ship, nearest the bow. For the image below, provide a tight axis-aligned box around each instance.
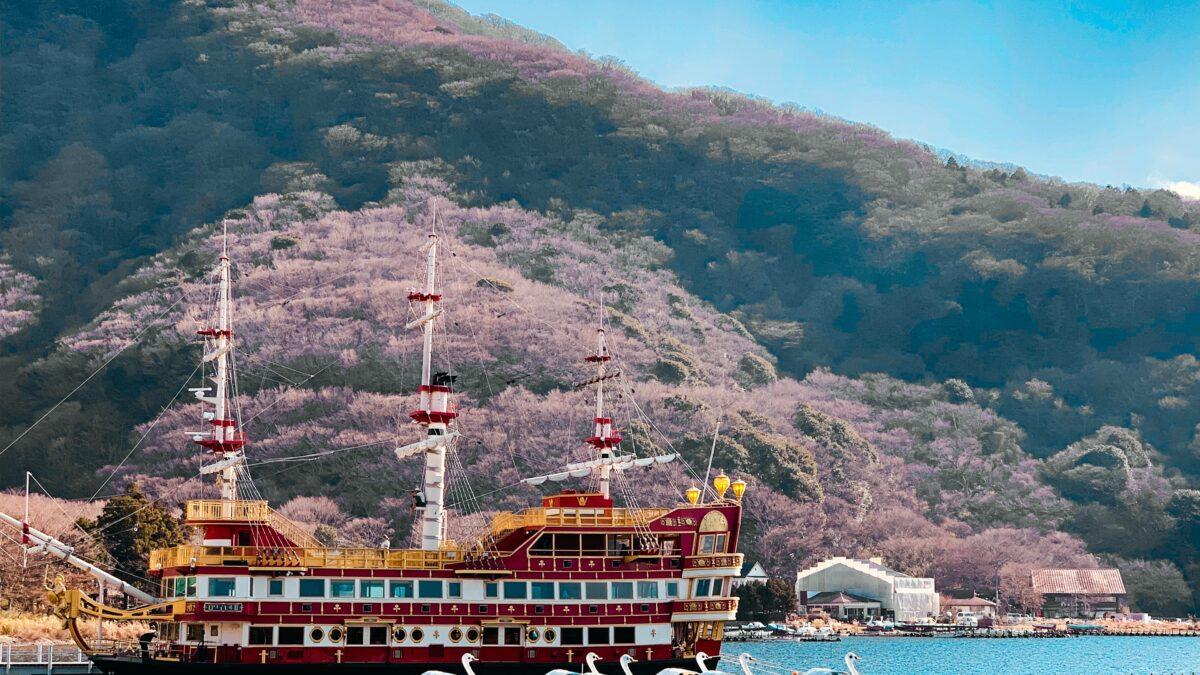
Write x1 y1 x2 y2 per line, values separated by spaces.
188 222 246 501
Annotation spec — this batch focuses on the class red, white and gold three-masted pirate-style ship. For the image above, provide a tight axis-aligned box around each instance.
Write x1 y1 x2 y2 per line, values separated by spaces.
16 218 745 675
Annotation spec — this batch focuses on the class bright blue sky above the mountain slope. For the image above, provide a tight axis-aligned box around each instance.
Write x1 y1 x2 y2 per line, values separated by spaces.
454 0 1200 198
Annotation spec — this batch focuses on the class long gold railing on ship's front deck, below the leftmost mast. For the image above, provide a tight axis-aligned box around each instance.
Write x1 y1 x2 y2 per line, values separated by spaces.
150 546 464 569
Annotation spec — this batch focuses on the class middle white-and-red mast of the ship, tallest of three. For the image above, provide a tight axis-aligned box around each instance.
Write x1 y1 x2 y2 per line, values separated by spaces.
408 205 458 550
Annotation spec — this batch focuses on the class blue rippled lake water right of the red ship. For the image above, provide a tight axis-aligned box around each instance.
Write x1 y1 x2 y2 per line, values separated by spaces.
721 637 1200 675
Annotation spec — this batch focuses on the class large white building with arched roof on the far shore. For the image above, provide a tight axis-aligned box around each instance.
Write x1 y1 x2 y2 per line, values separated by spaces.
796 556 941 621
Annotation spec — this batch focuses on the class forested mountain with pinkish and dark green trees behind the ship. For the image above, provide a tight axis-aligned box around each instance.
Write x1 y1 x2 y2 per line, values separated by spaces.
0 0 1200 611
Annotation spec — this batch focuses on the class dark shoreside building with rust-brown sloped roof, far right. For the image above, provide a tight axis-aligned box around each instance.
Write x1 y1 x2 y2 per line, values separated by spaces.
1030 569 1126 617
